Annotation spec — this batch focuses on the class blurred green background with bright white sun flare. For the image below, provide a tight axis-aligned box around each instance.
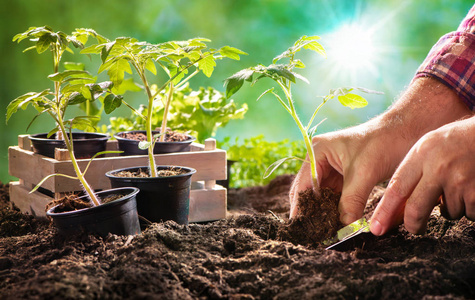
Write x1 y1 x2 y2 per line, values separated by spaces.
0 0 473 183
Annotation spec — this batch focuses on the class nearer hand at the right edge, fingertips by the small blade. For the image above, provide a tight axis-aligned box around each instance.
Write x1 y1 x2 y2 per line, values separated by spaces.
370 117 475 235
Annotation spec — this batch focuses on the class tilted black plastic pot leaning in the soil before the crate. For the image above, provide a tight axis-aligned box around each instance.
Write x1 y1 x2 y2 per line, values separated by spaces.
46 187 140 236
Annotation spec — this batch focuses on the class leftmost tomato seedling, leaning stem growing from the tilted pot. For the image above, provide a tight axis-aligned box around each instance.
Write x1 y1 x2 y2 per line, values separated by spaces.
6 26 121 205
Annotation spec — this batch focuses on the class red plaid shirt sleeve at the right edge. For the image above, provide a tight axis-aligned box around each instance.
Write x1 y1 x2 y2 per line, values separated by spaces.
414 5 475 110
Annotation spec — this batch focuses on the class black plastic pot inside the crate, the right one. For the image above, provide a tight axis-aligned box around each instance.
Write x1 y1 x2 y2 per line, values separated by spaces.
114 130 196 155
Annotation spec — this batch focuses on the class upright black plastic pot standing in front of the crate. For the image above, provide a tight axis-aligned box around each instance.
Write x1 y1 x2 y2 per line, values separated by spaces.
106 166 196 225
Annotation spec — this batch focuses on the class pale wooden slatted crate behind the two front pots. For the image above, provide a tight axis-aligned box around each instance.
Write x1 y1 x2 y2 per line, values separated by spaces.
8 135 227 222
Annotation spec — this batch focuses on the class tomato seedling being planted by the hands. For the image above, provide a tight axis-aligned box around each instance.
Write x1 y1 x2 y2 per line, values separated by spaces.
225 36 384 186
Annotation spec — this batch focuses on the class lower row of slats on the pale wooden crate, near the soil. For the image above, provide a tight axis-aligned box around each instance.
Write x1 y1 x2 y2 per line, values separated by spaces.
10 182 227 222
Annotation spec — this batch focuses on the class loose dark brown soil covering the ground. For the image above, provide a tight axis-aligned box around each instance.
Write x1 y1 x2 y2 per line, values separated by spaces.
0 176 475 299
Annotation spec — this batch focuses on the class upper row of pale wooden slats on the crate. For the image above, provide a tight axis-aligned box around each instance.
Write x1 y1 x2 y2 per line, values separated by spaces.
9 141 226 193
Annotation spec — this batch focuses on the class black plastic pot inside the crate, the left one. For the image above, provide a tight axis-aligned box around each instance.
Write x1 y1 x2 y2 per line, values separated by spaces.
29 132 109 159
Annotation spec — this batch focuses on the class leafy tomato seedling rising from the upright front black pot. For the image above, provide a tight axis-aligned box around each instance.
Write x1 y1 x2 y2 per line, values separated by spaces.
81 37 246 177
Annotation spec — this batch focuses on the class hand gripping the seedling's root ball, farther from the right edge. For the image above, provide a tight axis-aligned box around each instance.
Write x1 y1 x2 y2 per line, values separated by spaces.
290 121 410 224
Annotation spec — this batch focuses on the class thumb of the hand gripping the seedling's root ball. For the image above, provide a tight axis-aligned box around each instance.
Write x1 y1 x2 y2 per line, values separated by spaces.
339 169 377 225
